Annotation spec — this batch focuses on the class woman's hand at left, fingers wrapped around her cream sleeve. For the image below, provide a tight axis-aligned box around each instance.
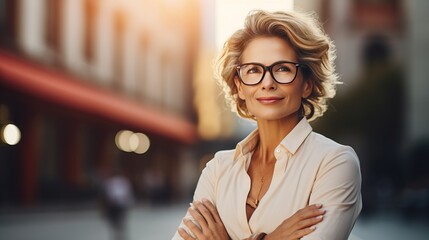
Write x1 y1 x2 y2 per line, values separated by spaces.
178 199 230 240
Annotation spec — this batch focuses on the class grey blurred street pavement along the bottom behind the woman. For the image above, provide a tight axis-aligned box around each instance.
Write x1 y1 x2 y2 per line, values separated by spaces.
0 205 429 240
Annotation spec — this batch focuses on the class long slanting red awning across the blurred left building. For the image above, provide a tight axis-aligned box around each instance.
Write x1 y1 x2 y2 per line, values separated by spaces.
0 50 197 143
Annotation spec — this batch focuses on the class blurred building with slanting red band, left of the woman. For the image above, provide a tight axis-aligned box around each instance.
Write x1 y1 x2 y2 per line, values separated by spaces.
0 0 200 206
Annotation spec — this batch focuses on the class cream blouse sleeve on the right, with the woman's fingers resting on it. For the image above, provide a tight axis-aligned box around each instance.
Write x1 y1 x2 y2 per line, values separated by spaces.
302 146 362 240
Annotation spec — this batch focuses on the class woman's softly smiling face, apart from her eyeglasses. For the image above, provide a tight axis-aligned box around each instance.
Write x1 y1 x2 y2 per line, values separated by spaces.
234 37 312 120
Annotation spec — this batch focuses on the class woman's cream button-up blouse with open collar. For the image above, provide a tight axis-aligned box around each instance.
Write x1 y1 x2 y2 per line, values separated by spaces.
173 118 362 240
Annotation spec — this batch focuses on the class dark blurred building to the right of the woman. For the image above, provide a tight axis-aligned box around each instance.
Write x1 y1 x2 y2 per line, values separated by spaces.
295 0 429 213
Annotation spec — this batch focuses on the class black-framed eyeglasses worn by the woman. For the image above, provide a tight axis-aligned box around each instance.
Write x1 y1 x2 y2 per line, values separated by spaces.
236 61 301 86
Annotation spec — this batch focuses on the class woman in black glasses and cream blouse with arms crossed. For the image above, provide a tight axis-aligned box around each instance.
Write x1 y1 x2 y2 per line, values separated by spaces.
173 11 362 240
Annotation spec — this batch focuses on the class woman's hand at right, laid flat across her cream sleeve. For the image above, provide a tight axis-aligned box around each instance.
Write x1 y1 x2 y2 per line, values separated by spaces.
264 204 325 240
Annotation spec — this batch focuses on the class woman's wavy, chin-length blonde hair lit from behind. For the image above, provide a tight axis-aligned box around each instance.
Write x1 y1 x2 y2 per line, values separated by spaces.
215 10 340 121
